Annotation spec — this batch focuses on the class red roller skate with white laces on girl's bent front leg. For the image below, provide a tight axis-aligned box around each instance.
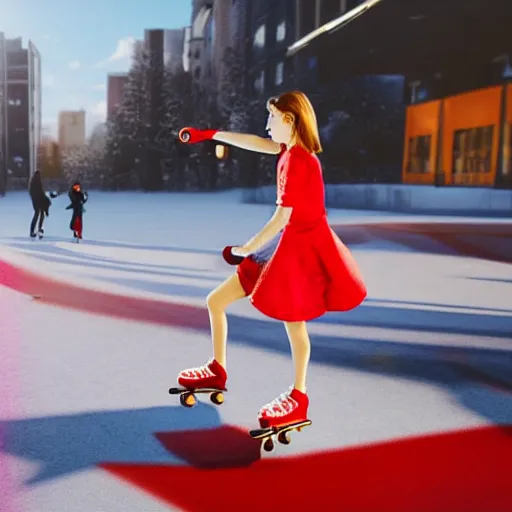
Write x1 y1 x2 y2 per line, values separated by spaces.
169 359 228 407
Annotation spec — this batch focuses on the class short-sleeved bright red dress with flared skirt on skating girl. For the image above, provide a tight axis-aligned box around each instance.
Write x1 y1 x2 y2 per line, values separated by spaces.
237 146 367 322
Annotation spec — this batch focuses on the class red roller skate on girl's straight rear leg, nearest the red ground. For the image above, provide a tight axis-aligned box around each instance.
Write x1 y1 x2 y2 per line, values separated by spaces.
249 388 311 452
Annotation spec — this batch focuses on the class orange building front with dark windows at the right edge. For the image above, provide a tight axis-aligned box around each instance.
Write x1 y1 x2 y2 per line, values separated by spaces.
402 84 512 187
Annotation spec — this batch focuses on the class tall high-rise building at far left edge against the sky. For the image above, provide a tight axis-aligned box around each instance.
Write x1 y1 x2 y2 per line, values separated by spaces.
0 35 42 190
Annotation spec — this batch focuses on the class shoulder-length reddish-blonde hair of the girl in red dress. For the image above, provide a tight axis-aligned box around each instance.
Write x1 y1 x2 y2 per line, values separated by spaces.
267 91 322 153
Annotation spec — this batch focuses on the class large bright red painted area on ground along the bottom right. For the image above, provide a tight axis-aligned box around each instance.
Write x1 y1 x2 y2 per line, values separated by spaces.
101 419 512 512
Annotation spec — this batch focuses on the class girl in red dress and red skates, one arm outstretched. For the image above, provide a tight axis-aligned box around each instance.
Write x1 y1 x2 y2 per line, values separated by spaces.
174 91 367 428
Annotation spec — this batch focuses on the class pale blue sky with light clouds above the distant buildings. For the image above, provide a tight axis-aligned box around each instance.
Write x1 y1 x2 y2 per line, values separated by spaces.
0 0 192 136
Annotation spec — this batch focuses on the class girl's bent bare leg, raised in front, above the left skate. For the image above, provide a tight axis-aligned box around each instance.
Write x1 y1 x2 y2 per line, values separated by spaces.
206 273 246 369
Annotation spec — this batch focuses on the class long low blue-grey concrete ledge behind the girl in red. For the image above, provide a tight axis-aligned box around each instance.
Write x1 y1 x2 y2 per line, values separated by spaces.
243 184 512 217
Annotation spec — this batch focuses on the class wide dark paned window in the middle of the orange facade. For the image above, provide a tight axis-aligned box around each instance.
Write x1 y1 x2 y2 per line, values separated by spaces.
452 125 494 178
